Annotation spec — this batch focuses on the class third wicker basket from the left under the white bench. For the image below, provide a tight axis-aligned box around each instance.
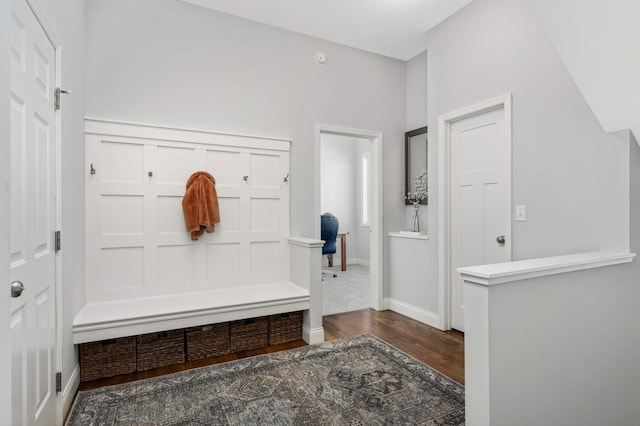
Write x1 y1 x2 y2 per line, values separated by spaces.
185 322 231 361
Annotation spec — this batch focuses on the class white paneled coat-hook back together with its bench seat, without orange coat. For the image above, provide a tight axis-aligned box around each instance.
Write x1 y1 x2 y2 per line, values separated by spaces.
74 119 322 343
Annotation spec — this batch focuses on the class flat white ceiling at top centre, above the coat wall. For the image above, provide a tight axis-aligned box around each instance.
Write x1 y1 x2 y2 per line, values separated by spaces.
183 0 473 61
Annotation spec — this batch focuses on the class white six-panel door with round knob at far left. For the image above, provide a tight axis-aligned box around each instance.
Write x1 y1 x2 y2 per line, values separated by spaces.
10 0 56 425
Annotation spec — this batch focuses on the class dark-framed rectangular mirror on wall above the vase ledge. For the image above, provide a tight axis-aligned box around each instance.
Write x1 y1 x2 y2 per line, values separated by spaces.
404 126 429 206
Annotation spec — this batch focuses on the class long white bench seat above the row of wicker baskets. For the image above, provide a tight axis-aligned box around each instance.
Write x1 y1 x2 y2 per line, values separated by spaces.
73 281 310 344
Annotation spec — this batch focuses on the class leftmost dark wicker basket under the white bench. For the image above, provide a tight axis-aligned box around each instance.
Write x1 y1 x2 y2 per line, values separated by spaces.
80 337 136 382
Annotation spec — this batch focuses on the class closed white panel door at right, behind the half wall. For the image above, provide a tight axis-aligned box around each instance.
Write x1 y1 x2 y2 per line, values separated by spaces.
450 107 511 331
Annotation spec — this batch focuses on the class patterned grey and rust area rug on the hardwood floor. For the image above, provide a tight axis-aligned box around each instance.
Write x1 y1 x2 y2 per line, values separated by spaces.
67 334 464 425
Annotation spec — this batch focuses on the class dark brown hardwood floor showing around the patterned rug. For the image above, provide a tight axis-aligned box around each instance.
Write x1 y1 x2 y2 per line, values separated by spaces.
79 309 464 391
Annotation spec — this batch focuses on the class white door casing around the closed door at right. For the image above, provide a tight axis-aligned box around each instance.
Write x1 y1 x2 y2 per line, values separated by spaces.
437 93 512 330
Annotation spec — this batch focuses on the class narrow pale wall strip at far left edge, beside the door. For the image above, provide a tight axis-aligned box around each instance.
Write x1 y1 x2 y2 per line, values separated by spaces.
0 0 11 425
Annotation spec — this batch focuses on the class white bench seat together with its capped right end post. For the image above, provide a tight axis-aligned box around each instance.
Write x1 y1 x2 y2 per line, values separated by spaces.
73 238 324 344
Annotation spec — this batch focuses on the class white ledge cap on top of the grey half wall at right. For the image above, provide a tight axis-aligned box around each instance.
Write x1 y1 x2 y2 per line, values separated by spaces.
458 251 635 285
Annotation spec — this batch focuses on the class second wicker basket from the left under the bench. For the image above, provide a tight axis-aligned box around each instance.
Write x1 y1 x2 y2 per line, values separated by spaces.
136 329 184 371
